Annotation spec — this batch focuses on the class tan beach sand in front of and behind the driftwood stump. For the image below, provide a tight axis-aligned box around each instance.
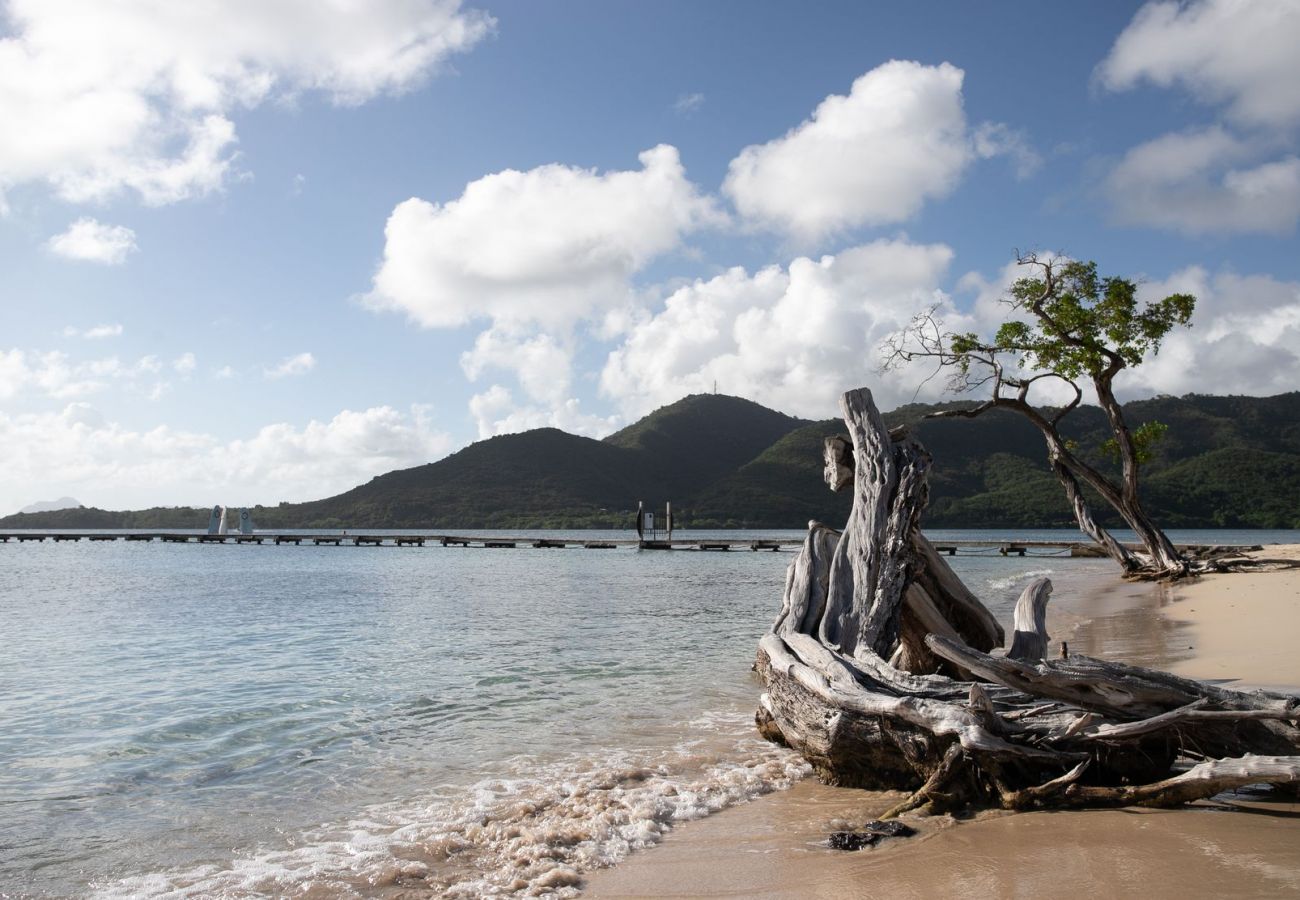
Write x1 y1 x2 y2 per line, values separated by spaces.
584 546 1300 900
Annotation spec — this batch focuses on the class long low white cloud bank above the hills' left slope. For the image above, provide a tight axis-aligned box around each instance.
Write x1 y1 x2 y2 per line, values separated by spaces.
0 400 451 512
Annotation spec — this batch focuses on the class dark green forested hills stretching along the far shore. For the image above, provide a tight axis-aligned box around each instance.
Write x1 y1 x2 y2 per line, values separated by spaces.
0 391 1300 528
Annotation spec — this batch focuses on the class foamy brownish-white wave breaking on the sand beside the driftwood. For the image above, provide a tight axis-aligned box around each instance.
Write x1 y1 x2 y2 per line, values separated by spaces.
94 722 809 899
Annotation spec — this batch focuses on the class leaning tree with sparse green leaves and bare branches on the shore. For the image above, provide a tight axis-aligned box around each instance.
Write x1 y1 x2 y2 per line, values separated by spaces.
885 254 1196 577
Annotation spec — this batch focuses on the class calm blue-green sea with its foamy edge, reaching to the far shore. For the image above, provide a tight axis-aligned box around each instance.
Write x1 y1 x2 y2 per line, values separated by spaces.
0 522 1300 897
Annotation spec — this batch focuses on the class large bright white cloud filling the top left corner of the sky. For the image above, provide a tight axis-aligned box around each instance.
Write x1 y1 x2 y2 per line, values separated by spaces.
0 0 493 204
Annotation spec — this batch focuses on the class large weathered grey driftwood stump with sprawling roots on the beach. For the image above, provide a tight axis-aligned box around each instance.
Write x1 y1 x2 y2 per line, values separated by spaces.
755 389 1300 818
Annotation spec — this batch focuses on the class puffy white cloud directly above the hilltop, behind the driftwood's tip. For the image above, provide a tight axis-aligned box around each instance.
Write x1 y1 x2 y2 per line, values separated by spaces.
601 241 952 420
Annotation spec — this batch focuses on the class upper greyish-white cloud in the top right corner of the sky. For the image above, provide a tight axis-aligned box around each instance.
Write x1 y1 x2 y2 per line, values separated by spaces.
1097 0 1300 127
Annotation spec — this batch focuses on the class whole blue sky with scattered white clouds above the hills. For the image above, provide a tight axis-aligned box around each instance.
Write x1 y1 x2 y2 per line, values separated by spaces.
0 0 1300 514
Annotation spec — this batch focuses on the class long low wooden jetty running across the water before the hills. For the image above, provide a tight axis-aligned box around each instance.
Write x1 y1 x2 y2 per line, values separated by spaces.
0 531 1262 557
